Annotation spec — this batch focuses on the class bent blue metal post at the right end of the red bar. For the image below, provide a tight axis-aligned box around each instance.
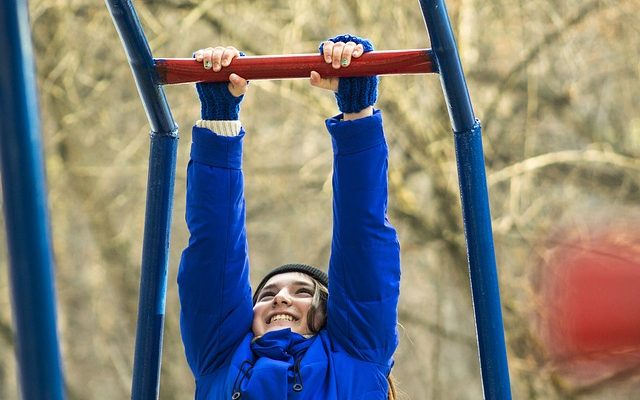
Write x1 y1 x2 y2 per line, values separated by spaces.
420 0 511 400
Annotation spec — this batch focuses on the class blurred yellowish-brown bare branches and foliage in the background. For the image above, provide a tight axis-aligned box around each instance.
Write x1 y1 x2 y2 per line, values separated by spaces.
0 0 640 400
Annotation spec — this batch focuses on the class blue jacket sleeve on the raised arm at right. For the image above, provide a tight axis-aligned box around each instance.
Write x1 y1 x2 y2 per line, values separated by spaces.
327 111 400 367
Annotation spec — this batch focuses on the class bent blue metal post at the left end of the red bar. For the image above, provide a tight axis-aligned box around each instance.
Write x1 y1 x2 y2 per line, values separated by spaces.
106 0 178 400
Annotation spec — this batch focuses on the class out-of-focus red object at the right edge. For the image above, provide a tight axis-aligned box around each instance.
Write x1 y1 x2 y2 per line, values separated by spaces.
541 229 640 366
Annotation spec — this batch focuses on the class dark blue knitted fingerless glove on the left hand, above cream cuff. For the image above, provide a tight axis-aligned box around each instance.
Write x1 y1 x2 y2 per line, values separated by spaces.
196 53 244 121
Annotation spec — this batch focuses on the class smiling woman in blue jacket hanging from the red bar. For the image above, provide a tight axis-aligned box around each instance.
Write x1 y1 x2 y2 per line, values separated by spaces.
178 35 400 400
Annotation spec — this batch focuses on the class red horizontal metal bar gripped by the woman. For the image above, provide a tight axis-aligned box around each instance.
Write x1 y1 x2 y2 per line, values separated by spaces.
154 49 437 85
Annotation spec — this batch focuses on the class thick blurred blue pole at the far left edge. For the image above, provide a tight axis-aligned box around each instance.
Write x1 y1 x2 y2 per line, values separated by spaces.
0 0 64 400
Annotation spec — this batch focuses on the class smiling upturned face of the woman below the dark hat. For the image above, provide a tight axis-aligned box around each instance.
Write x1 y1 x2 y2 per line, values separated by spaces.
252 272 323 336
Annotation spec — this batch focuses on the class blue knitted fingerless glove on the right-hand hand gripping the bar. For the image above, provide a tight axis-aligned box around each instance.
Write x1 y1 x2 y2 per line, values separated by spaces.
320 34 378 113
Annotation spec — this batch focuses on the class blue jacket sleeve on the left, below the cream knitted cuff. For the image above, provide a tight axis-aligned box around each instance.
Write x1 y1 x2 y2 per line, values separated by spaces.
178 127 253 378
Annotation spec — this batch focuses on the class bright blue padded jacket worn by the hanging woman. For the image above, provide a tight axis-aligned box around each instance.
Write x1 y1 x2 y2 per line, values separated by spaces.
178 111 400 400
